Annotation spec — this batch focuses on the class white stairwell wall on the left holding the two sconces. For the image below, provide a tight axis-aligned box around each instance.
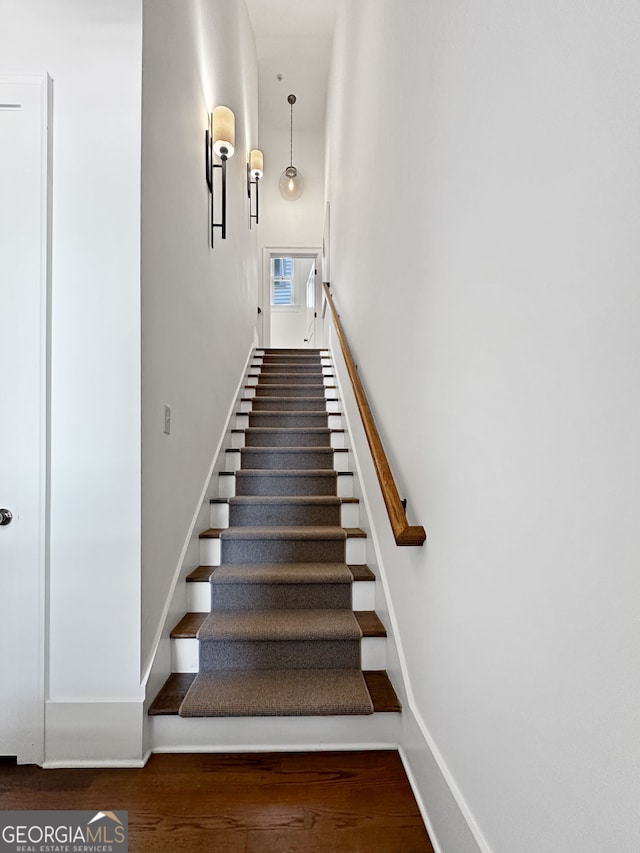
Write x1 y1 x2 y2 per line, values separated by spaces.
142 0 258 680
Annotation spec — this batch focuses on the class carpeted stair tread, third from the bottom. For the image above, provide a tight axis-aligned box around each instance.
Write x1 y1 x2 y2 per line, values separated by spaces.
209 563 353 584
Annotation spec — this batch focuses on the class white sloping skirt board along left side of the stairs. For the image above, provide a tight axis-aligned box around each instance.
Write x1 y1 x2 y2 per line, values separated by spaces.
141 339 259 724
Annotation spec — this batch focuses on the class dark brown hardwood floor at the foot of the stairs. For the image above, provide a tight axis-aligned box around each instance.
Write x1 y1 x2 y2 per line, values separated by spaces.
0 751 433 853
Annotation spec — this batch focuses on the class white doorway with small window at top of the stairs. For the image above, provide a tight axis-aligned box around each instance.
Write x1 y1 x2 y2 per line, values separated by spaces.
262 248 320 349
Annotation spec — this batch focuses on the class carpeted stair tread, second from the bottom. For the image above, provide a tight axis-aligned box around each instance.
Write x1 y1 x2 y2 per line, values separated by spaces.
197 609 362 642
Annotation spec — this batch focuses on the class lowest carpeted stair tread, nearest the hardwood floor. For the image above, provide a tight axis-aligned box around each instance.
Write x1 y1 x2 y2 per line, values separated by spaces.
179 669 373 717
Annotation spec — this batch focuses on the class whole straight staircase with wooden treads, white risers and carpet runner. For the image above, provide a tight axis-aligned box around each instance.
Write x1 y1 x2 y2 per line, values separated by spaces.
149 350 400 740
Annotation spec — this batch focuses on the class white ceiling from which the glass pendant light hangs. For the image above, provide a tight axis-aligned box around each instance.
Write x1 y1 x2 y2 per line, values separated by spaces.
246 0 340 133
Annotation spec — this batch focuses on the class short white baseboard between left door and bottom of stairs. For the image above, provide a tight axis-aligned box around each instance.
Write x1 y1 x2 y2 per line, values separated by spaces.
43 699 145 768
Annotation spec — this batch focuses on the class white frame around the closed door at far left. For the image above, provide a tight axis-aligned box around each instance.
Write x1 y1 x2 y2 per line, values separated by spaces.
0 74 53 765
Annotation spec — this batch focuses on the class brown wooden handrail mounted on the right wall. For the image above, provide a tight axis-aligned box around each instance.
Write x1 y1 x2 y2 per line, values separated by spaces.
323 282 427 545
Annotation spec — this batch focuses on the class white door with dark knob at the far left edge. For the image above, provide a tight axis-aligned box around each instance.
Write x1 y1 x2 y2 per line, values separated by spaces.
0 76 48 763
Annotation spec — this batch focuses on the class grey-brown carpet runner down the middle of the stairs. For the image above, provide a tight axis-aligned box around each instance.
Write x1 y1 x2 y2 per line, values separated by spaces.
180 350 373 717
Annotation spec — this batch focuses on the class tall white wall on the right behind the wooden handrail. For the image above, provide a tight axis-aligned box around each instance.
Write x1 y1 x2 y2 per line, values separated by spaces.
327 0 640 853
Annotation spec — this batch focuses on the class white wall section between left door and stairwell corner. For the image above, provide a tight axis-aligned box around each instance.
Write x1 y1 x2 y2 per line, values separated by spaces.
0 0 142 760
